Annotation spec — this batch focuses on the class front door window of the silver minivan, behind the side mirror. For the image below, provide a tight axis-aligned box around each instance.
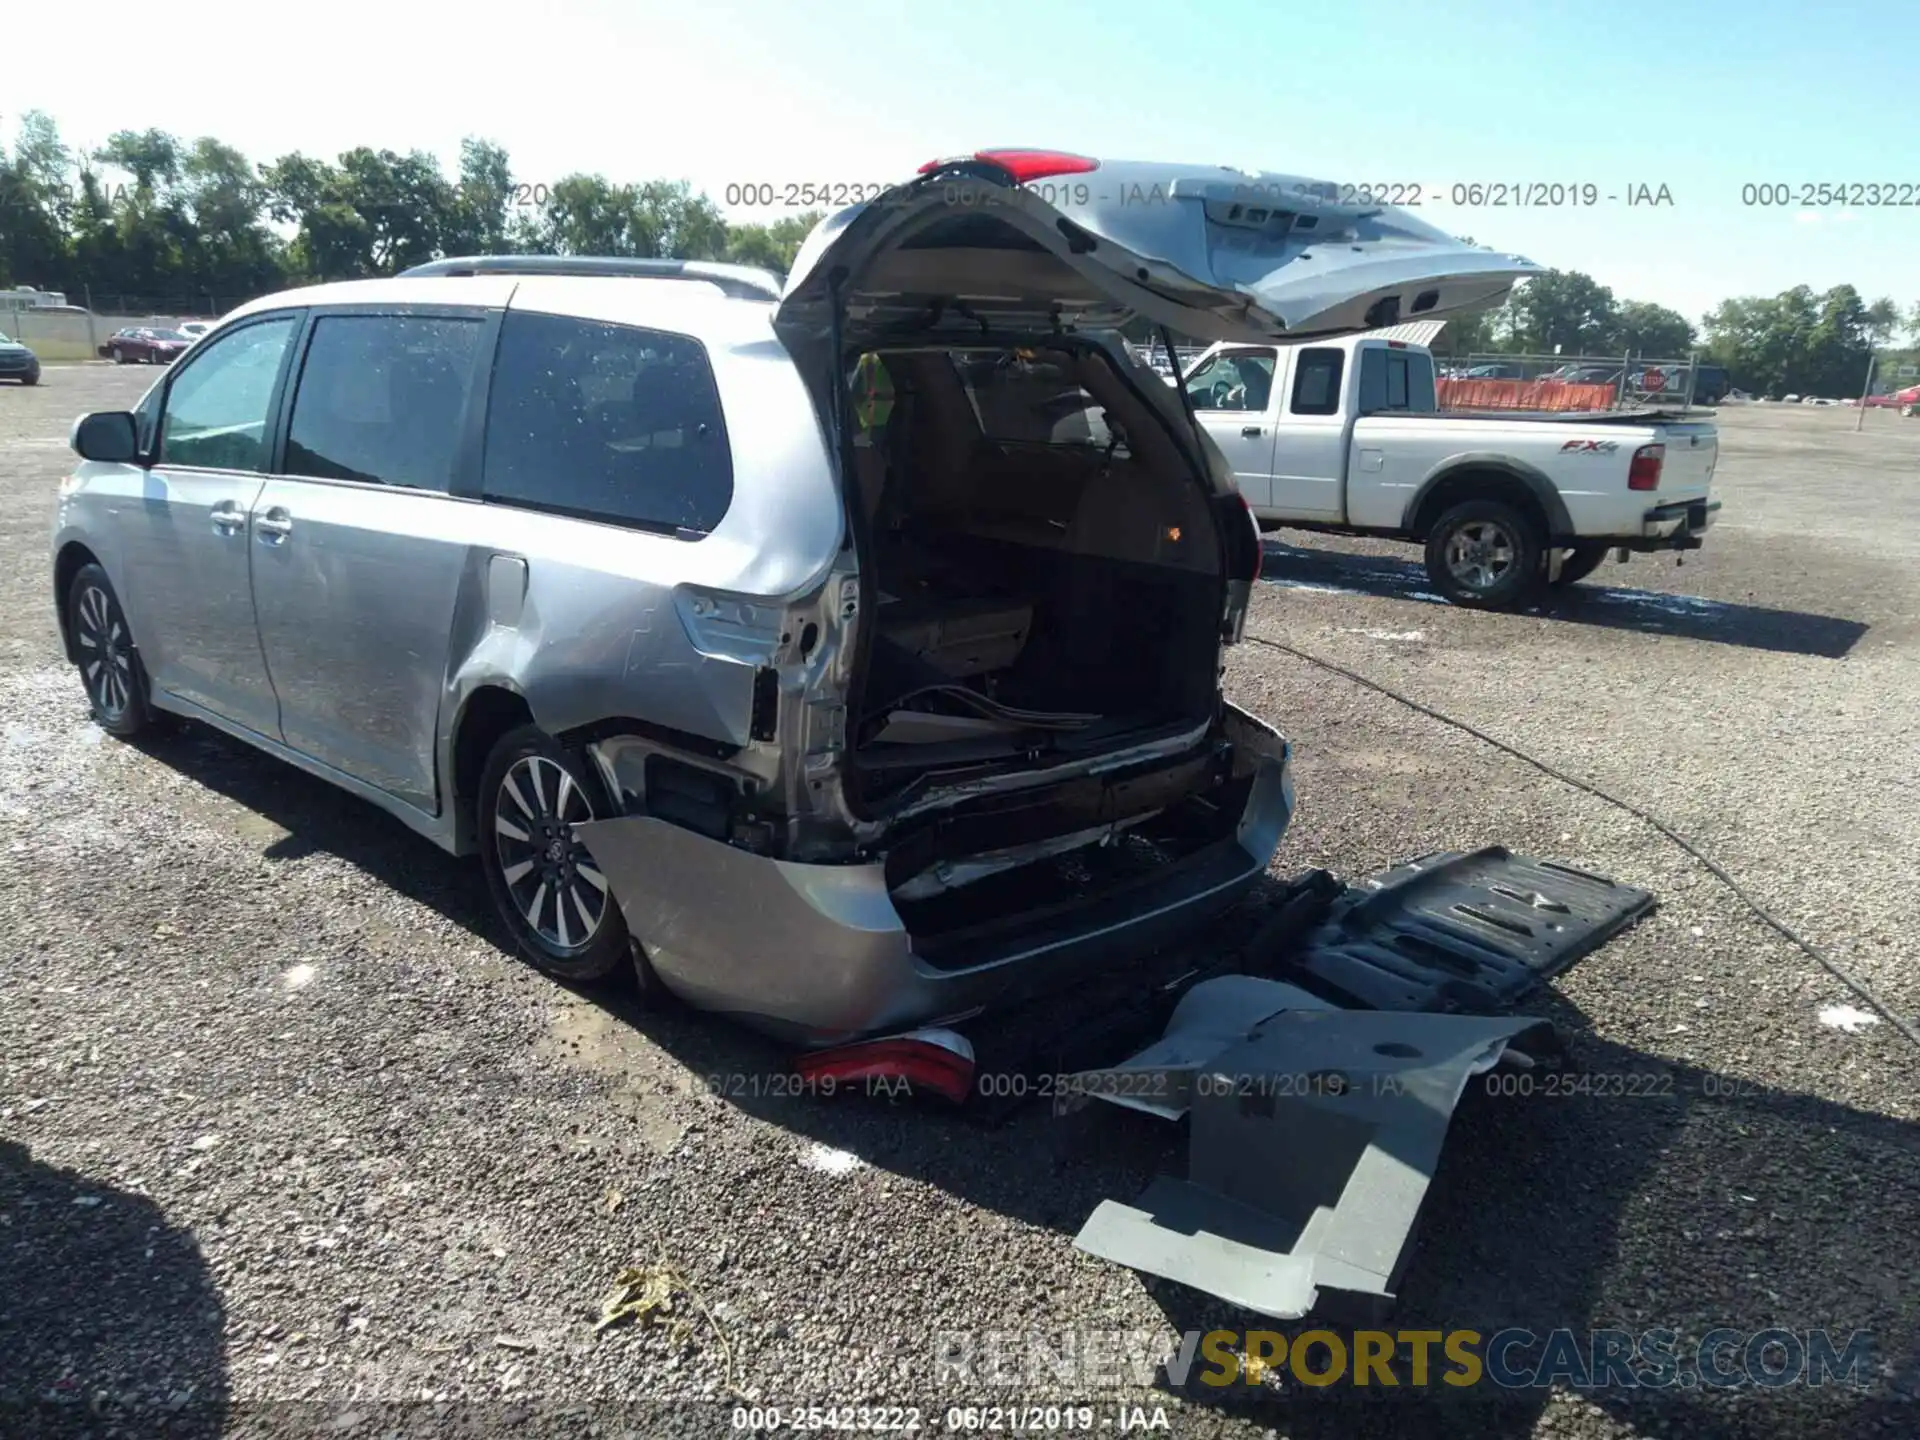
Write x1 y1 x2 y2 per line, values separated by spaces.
159 315 300 472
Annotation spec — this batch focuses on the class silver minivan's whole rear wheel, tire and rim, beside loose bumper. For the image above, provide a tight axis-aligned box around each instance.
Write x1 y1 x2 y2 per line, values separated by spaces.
474 726 632 983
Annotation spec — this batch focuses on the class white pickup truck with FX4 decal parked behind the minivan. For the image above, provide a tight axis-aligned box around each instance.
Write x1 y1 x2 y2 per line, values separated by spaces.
1181 336 1720 609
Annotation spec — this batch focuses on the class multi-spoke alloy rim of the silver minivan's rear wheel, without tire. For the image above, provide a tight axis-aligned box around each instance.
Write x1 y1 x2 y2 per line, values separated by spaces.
493 755 609 952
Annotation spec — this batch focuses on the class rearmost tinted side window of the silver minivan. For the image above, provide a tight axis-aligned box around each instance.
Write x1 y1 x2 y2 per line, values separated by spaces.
482 311 733 534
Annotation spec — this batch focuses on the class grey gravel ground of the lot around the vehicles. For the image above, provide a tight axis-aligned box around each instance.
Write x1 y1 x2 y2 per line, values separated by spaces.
0 374 1920 1436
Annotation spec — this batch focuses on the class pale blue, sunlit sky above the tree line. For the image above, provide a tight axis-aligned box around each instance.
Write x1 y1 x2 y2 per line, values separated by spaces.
0 0 1920 323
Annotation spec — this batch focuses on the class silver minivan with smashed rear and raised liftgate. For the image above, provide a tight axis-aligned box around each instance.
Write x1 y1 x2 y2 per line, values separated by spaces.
52 152 1534 1044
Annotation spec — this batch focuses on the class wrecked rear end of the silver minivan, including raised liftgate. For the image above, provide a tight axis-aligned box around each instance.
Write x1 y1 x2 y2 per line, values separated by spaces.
578 152 1532 1044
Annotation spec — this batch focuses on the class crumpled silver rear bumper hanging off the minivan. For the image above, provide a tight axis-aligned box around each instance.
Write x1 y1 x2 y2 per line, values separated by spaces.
576 737 1294 1044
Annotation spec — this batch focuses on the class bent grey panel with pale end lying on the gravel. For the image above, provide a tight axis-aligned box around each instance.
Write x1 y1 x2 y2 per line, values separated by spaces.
1075 998 1542 1319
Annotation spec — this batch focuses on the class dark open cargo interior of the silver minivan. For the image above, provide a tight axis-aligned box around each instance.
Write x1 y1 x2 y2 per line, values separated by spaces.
852 348 1221 810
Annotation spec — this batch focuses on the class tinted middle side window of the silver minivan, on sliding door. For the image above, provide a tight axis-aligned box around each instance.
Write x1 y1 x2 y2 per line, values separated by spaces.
284 315 482 490
